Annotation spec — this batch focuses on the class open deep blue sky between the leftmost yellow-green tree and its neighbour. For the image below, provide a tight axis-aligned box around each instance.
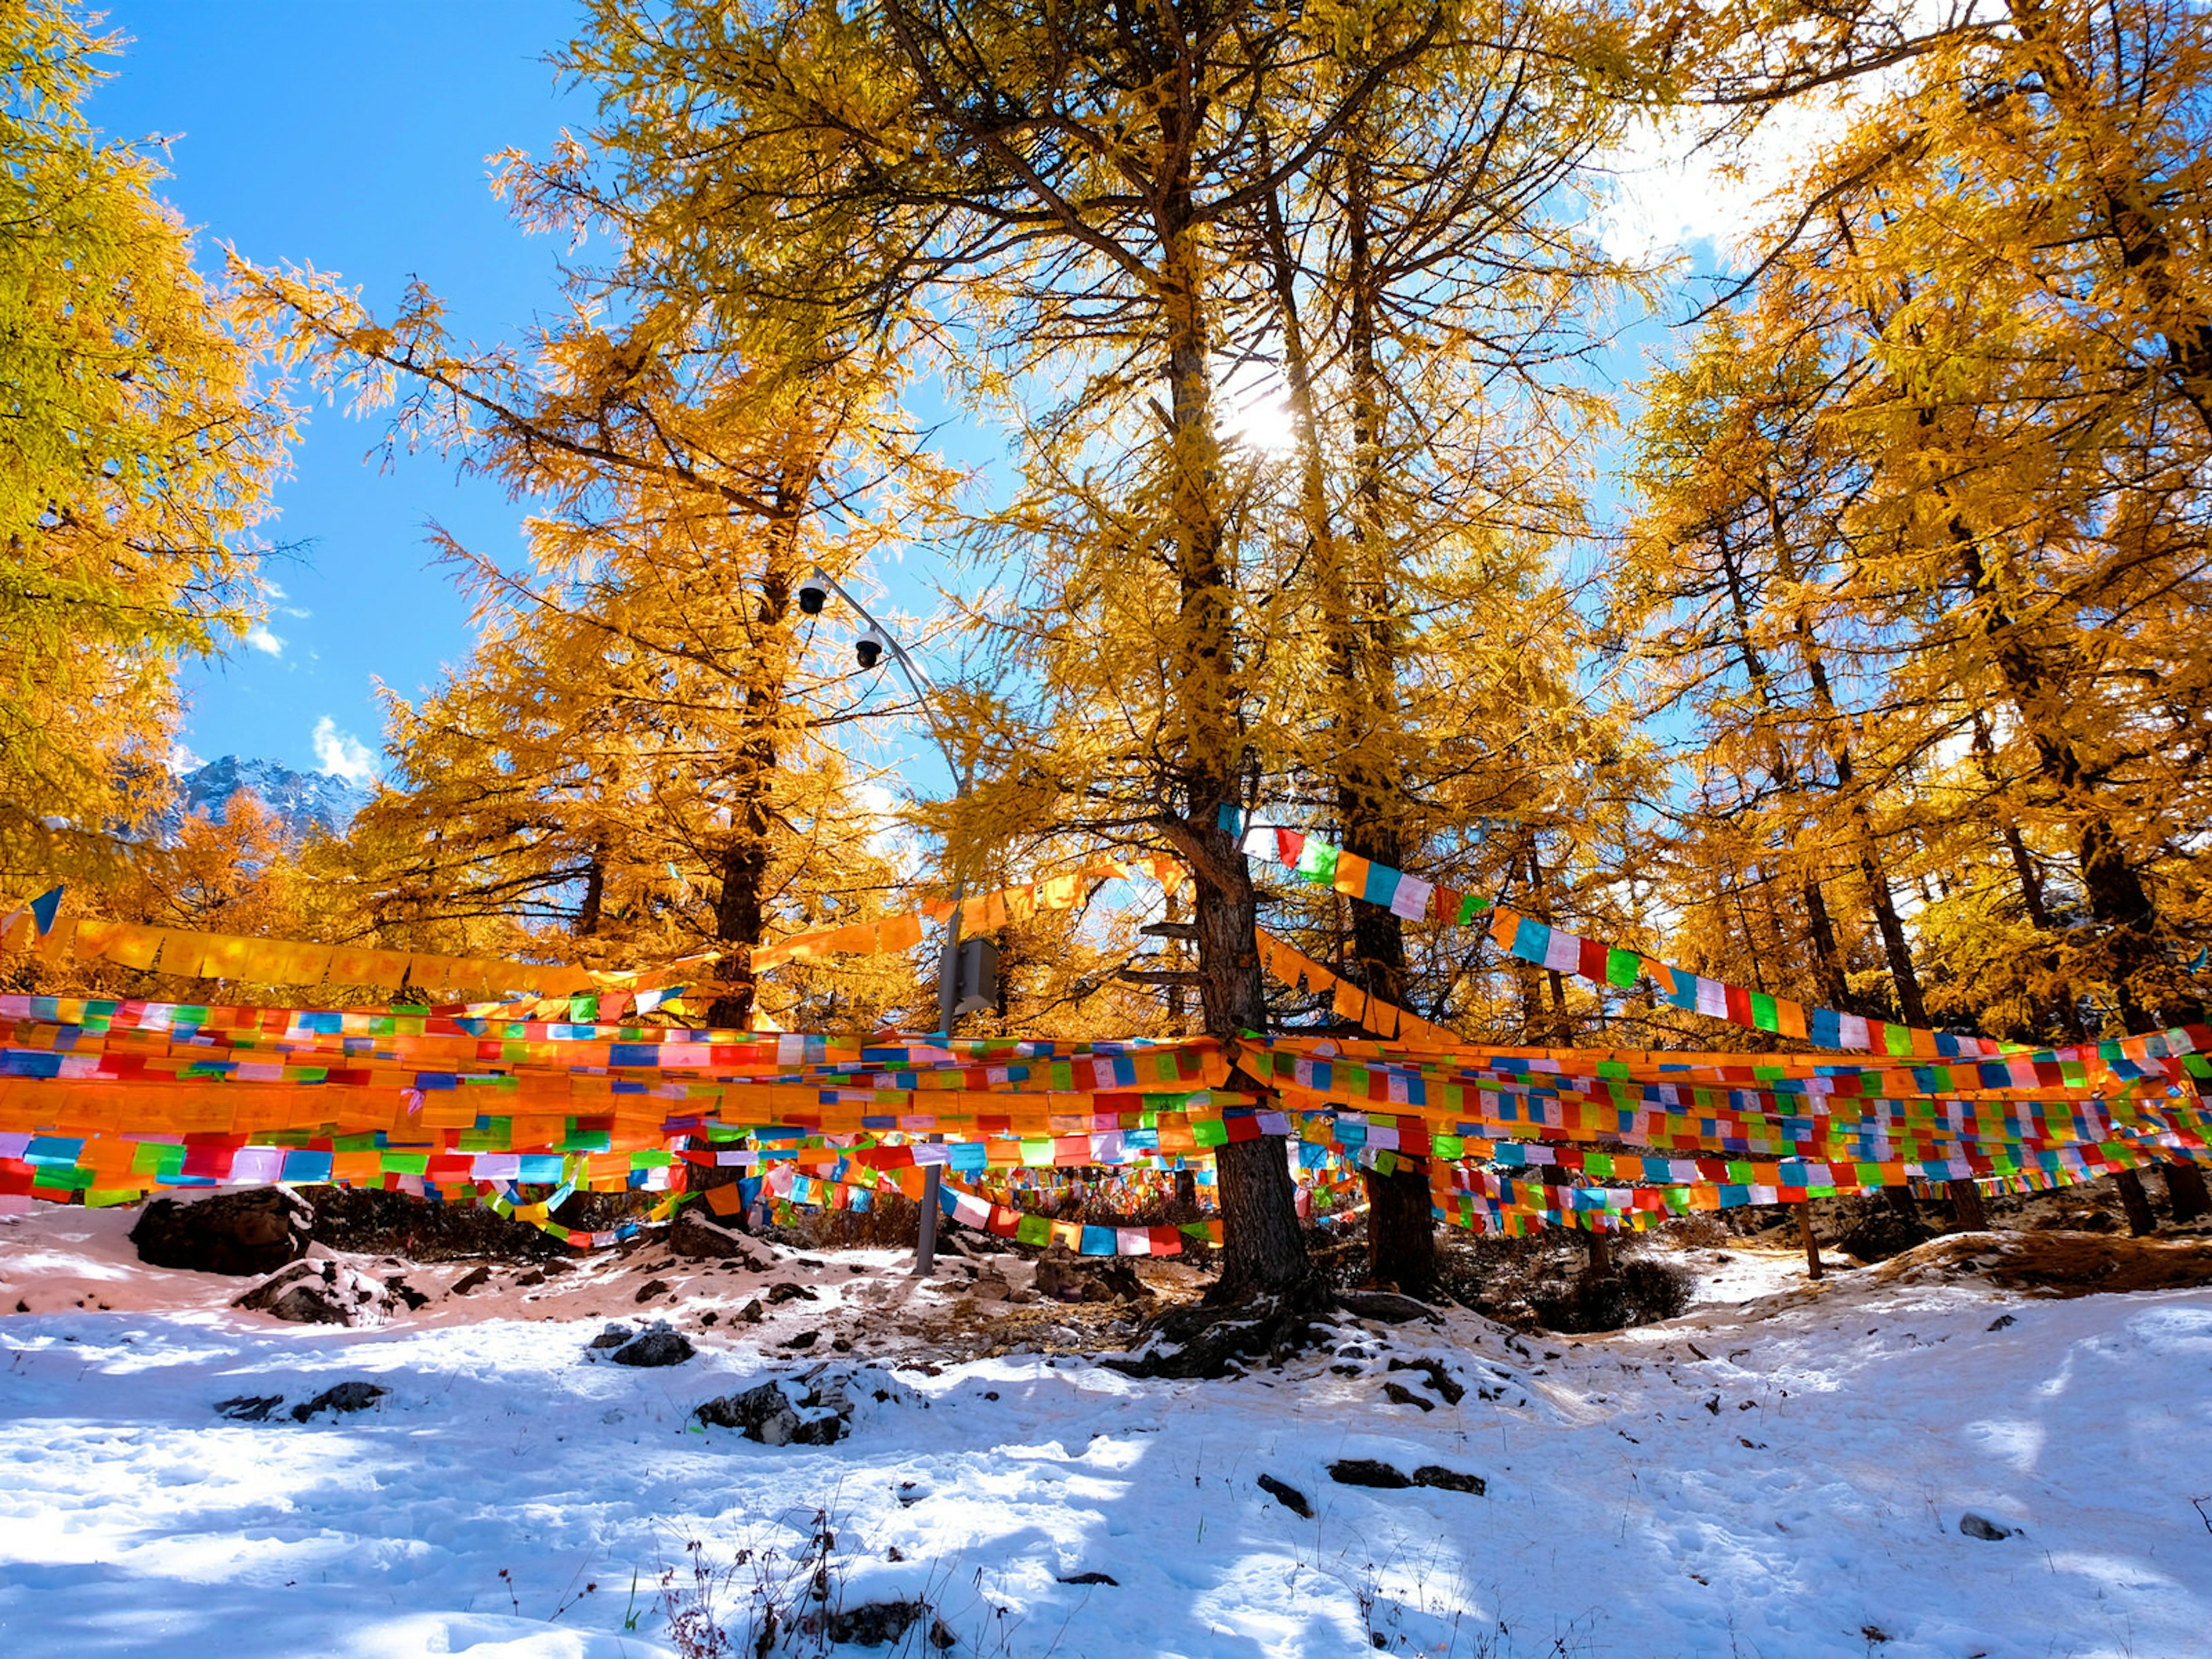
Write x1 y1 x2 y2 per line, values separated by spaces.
90 0 588 783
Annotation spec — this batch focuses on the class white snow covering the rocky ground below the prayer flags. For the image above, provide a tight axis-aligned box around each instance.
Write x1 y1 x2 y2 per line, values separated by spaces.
0 1210 2212 1659
